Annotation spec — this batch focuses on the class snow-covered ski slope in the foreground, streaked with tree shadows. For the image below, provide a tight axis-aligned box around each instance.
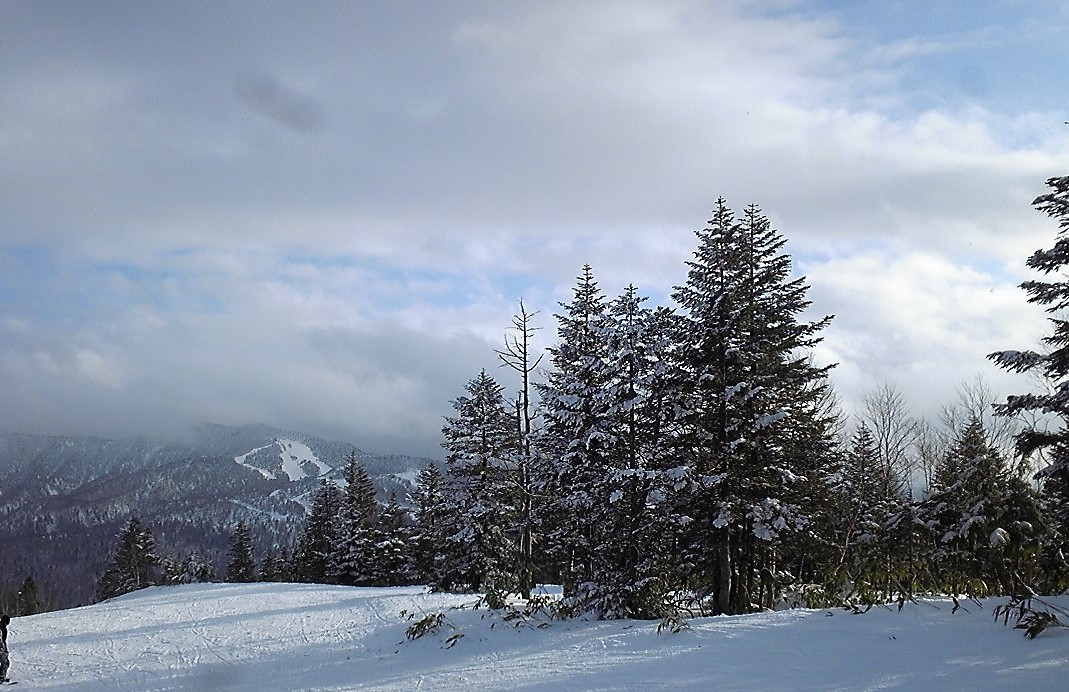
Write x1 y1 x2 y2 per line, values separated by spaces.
10 584 1069 692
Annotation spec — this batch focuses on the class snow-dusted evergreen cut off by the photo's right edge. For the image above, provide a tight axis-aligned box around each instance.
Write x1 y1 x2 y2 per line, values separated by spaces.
988 175 1069 590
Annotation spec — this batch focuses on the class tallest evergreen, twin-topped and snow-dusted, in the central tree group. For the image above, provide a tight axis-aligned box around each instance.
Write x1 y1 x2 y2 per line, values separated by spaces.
673 199 830 613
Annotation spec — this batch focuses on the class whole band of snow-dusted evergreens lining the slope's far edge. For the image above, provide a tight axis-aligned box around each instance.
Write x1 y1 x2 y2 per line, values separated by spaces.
19 176 1069 621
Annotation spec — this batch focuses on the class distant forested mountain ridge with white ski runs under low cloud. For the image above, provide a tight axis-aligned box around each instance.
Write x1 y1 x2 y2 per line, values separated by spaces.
0 425 431 605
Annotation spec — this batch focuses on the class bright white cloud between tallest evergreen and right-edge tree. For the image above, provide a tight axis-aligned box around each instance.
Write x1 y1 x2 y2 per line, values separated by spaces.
804 251 1045 419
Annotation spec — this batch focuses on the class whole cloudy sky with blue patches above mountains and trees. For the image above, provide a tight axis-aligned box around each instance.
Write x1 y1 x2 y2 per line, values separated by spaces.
0 0 1069 457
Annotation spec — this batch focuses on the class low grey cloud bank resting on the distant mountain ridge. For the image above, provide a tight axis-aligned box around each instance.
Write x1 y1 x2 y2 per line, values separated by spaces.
0 256 493 456
